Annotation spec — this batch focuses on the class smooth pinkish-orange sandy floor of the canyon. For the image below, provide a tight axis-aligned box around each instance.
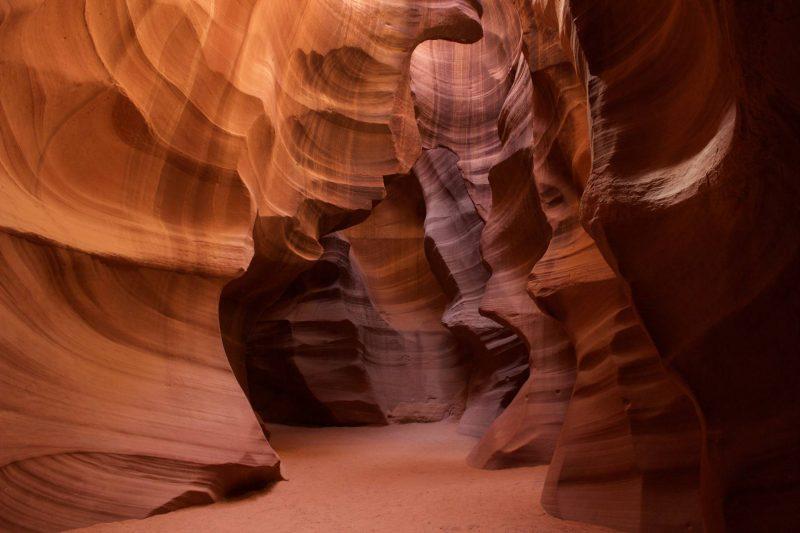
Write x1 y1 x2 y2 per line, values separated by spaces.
76 422 608 533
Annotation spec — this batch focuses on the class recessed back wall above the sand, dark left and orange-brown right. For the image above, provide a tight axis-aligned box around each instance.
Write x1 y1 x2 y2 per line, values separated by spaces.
246 175 476 424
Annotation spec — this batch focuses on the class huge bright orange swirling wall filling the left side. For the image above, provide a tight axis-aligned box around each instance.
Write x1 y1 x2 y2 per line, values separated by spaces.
0 0 481 530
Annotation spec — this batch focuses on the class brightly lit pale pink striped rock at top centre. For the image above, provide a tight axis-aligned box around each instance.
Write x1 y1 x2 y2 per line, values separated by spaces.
411 0 522 219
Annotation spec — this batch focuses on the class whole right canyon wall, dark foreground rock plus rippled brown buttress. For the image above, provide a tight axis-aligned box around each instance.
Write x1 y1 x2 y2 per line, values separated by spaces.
506 1 800 531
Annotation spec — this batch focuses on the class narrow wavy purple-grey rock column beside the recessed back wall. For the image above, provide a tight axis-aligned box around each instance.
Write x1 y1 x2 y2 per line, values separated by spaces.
414 148 529 436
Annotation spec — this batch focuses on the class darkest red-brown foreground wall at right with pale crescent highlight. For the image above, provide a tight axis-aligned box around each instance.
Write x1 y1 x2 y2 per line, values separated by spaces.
573 1 800 531
